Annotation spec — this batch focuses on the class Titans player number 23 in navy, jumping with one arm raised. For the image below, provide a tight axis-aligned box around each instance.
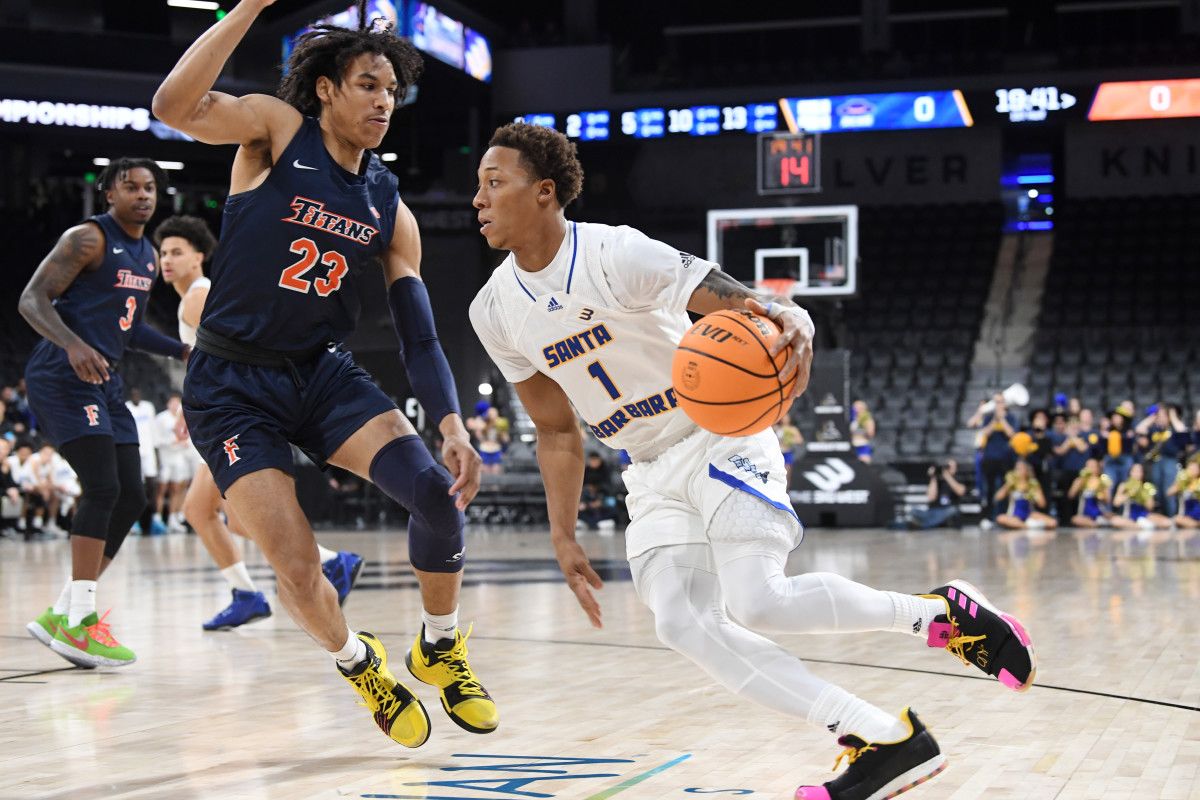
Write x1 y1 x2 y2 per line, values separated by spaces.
154 0 498 747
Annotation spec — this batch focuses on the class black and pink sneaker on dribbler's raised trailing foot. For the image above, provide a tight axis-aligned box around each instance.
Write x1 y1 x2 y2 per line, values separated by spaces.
922 581 1038 692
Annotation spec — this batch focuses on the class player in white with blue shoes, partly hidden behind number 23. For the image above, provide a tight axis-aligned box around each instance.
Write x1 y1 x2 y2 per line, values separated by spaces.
154 216 362 631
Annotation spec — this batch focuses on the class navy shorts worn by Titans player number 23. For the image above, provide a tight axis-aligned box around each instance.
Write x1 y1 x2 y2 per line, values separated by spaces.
184 349 396 497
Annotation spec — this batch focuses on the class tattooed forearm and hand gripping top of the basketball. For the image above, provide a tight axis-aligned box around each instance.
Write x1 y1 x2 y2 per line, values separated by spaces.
688 269 816 397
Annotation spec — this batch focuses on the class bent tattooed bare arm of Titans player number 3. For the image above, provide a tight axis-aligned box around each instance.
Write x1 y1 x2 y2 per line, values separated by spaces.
17 222 108 384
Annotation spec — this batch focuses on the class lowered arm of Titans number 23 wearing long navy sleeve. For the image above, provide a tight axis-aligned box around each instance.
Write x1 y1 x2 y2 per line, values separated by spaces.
384 203 481 510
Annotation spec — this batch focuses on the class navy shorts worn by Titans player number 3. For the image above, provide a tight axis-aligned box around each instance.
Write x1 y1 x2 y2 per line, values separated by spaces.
25 339 138 447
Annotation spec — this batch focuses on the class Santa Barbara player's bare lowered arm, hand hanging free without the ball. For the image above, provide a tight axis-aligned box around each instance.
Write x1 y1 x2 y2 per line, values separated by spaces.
514 372 604 627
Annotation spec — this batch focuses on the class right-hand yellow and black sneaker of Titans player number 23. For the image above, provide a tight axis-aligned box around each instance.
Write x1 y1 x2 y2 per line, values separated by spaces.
404 628 500 733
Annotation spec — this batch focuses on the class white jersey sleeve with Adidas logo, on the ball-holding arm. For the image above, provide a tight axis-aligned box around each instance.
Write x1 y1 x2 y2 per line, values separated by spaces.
602 225 721 313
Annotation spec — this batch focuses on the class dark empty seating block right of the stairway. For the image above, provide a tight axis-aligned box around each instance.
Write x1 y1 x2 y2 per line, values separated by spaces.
1030 197 1200 410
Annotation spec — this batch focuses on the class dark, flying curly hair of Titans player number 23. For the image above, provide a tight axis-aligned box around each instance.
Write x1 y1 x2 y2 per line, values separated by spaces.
276 0 425 116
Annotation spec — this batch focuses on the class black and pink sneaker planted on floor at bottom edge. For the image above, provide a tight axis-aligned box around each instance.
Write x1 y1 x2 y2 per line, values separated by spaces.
796 709 946 800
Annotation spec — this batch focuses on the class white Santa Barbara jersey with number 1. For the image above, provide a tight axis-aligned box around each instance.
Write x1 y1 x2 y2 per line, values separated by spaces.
470 222 719 461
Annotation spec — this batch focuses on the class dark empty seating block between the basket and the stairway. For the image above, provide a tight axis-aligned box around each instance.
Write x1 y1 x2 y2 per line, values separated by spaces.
845 203 1002 461
